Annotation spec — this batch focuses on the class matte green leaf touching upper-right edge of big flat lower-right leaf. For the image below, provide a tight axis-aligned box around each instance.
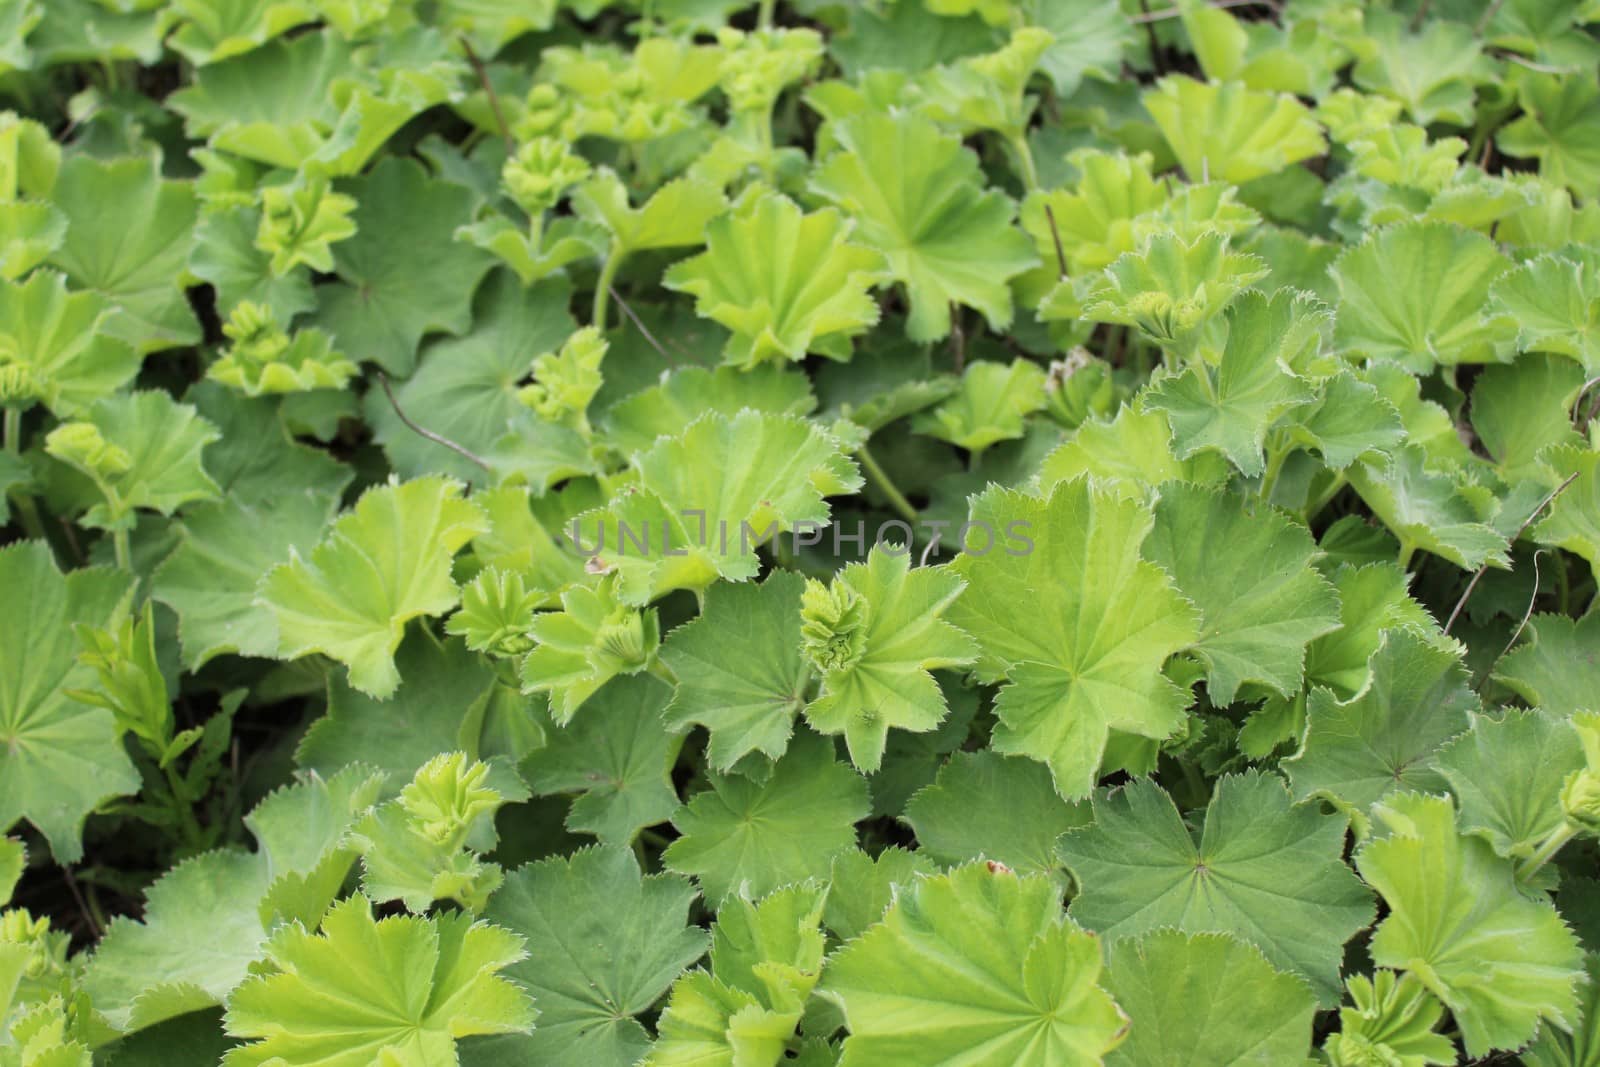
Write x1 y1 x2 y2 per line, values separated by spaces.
1283 627 1478 816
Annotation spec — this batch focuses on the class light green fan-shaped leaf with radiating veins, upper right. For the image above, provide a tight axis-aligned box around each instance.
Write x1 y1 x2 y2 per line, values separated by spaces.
1331 221 1515 374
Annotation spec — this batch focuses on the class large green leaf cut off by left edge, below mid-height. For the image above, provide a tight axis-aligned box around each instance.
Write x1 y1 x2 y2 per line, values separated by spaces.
0 541 139 864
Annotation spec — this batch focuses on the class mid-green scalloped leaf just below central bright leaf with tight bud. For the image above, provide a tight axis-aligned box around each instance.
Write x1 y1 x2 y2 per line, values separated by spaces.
662 733 870 901
